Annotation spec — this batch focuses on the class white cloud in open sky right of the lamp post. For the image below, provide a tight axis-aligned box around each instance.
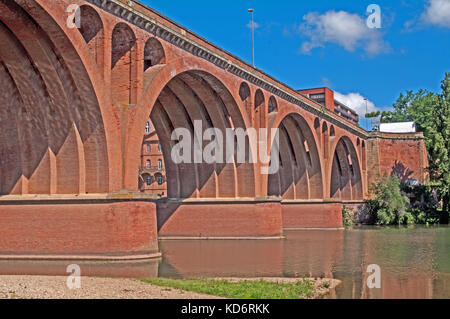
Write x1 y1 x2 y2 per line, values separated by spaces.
298 10 390 55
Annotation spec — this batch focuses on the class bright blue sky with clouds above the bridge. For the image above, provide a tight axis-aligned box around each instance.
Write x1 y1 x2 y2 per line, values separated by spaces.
142 0 450 130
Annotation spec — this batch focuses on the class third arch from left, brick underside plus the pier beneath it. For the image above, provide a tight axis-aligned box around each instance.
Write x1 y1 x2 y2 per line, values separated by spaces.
268 113 342 229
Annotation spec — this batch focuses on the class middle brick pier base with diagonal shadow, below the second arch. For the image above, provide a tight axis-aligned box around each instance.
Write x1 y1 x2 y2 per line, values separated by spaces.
158 199 283 239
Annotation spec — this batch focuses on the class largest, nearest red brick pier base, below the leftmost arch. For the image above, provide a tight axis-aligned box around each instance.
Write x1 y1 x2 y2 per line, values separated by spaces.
0 195 161 260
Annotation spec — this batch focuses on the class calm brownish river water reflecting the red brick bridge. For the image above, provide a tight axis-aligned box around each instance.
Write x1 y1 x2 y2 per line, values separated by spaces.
0 226 450 299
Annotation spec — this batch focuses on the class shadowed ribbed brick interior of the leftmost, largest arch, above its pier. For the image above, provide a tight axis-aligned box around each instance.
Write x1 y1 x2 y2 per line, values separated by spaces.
0 0 109 194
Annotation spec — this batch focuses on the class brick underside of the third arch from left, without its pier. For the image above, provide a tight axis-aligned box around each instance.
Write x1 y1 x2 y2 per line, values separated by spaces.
268 113 323 200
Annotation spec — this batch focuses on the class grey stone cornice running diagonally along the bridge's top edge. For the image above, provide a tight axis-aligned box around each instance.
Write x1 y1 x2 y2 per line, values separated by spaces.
86 0 368 139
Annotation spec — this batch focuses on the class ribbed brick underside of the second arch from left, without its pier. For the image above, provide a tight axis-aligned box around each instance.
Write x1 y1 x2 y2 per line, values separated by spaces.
146 71 255 199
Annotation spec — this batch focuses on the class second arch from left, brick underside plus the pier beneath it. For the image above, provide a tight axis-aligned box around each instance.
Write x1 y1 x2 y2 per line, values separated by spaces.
150 70 282 238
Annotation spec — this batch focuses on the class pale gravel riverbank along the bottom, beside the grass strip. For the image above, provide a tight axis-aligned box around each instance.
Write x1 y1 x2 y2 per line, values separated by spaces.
0 276 339 299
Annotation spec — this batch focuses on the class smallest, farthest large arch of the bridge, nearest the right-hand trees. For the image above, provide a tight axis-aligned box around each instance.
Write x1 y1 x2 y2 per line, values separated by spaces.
329 136 363 200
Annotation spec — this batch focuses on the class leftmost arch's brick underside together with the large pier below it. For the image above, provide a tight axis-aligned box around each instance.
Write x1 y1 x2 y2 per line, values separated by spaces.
0 0 160 259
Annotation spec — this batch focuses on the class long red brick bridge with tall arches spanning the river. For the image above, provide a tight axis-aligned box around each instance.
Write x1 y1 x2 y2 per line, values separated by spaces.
0 0 426 259
